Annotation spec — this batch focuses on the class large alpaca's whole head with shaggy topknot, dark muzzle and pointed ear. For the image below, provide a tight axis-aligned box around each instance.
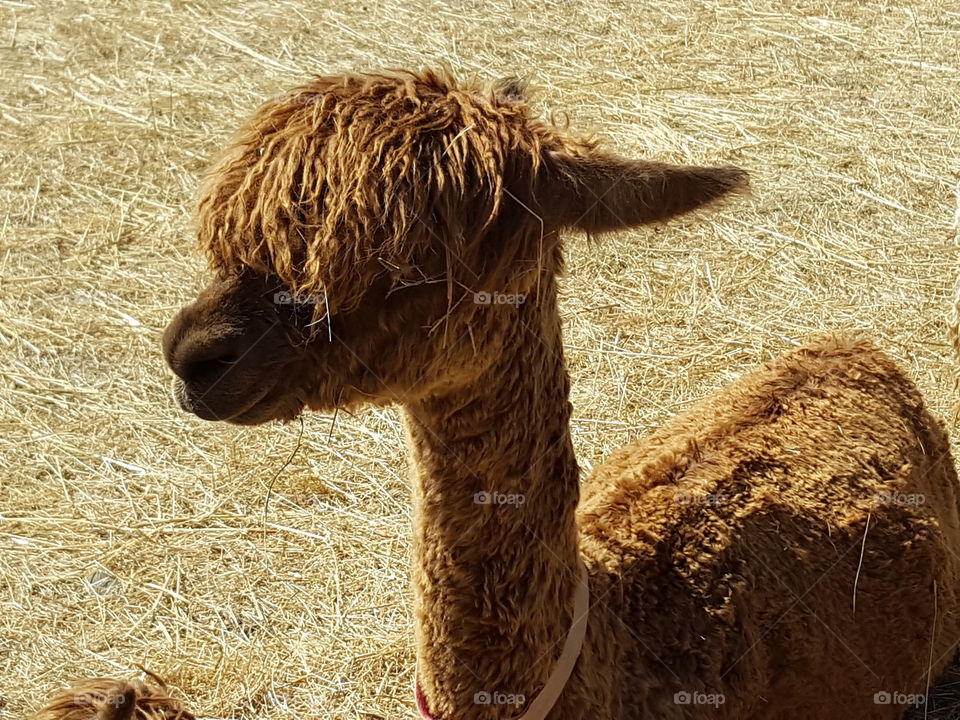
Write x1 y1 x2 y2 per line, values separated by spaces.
164 73 746 424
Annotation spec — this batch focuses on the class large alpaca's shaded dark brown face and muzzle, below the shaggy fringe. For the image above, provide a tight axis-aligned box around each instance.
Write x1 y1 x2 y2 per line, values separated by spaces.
163 258 516 425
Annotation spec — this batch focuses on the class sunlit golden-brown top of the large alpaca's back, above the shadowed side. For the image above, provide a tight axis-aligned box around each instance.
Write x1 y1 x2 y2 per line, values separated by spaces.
579 337 956 568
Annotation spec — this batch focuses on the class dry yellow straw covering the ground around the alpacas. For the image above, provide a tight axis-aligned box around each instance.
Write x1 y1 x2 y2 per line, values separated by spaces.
0 0 960 720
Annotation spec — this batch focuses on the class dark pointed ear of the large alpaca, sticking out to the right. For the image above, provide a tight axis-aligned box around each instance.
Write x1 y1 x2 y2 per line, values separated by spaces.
536 150 748 234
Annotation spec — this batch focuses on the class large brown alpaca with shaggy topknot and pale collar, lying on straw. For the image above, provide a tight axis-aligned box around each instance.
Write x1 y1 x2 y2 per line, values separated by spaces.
41 72 960 720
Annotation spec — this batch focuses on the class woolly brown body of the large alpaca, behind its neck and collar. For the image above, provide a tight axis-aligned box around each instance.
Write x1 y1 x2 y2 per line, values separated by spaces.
579 338 960 720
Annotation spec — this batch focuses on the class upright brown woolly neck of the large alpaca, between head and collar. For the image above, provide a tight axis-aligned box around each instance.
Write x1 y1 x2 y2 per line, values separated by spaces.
406 288 579 720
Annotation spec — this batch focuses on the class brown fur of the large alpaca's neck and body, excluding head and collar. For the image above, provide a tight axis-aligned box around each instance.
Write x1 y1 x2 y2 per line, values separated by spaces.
408 286 960 720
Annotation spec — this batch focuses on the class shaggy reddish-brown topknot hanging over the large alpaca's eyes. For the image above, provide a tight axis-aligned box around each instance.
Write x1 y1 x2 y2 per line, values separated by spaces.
197 72 593 312
